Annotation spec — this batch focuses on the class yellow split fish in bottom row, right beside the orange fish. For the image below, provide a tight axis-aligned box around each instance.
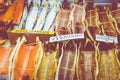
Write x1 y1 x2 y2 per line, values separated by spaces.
37 52 57 80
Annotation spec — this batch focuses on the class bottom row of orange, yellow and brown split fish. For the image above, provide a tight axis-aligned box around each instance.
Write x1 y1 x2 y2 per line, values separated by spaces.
0 37 120 80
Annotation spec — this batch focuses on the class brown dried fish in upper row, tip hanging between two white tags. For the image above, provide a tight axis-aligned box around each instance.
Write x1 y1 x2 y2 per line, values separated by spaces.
86 9 102 41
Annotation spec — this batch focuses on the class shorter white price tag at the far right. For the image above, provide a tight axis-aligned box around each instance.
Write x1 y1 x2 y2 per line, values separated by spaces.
96 35 118 43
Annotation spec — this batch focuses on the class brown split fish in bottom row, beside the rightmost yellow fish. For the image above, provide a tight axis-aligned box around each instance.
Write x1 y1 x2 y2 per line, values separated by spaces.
77 50 96 80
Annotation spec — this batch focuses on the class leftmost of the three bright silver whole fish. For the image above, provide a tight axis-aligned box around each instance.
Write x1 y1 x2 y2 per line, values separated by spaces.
25 4 38 30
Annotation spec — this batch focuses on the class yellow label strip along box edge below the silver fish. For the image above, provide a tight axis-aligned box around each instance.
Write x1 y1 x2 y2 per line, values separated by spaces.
11 30 55 35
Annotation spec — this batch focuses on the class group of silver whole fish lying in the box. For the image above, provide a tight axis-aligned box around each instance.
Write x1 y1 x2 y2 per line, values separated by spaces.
14 0 59 31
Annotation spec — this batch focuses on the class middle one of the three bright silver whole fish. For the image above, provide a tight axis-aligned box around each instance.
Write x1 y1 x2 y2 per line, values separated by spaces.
34 6 48 30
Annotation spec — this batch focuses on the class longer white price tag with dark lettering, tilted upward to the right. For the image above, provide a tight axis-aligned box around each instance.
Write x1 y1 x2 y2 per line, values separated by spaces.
49 33 84 42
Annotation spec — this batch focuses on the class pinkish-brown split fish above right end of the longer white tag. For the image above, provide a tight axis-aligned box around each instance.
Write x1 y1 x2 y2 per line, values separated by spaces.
70 4 86 33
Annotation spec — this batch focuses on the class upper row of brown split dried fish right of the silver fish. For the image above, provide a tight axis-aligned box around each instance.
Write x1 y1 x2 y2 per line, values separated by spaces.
56 4 120 37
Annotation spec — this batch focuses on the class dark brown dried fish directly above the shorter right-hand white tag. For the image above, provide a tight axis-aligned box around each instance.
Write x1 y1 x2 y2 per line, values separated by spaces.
98 11 117 36
